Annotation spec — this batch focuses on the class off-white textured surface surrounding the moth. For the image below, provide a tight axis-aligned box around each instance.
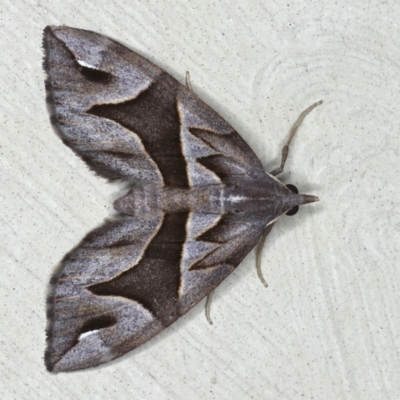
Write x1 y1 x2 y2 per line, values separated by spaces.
0 0 400 400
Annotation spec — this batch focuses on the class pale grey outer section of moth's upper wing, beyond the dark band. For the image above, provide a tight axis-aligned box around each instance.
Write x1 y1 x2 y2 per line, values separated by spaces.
43 26 163 184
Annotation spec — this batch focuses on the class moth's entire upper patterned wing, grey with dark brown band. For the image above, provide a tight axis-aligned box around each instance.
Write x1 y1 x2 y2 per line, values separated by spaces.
43 26 265 188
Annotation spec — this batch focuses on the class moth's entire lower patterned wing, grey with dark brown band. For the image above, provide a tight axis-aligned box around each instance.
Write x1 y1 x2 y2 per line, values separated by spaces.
45 213 266 371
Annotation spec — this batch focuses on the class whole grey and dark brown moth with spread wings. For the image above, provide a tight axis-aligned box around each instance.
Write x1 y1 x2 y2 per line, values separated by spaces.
43 26 320 372
